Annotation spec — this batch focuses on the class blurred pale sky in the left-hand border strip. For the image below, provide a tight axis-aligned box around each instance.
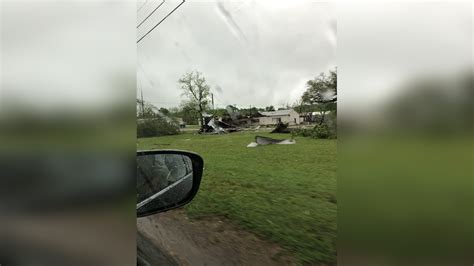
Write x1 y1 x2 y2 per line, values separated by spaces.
0 0 136 113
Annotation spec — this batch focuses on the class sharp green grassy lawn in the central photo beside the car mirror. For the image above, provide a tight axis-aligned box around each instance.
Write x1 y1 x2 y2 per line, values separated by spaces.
137 132 337 263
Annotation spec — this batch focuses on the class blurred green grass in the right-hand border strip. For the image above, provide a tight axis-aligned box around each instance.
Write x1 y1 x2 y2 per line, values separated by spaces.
338 137 474 265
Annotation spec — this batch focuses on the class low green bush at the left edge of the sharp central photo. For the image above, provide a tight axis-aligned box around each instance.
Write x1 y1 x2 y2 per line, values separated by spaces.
137 117 179 138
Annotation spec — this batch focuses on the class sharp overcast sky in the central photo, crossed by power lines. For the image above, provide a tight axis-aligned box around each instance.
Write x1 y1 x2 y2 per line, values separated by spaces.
137 0 336 107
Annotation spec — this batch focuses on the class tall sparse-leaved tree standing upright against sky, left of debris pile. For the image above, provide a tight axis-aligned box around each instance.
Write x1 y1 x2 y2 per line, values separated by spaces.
178 71 210 130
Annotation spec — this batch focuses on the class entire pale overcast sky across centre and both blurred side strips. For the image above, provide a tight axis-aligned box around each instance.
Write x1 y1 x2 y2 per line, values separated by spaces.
0 0 468 112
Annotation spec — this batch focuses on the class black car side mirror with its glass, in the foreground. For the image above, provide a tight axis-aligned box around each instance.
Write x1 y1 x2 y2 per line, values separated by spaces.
137 150 203 217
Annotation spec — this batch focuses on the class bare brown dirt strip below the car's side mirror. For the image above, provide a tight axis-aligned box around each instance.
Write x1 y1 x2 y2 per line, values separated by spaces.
137 210 296 265
